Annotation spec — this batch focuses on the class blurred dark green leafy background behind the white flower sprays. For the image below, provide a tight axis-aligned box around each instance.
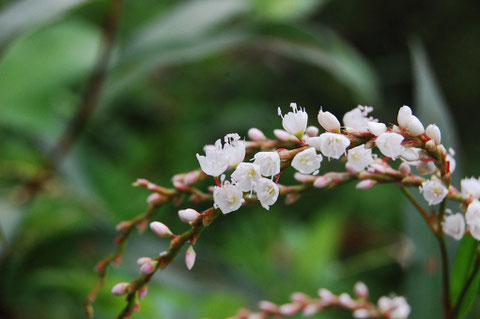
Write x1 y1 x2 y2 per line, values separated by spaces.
0 0 480 319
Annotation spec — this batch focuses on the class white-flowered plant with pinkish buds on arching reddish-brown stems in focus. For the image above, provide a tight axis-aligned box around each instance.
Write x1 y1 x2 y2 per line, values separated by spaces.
85 103 480 319
